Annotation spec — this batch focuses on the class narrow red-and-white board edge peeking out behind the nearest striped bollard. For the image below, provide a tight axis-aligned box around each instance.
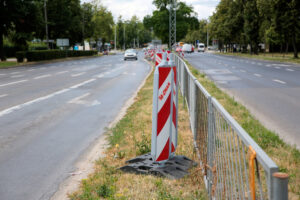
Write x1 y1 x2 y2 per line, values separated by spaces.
169 53 178 153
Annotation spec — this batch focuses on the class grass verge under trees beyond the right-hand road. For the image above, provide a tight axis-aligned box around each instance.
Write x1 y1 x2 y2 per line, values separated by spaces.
217 53 300 64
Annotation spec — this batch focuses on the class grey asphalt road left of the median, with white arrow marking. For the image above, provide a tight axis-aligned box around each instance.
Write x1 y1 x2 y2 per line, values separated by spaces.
0 52 150 200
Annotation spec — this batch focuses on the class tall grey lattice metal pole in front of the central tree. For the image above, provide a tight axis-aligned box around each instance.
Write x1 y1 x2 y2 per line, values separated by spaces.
169 0 177 50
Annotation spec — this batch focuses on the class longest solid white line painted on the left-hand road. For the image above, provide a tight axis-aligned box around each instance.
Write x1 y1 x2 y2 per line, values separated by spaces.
0 79 96 117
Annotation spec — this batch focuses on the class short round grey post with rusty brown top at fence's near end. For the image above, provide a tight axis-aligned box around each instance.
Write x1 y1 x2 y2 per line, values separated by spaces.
272 172 289 200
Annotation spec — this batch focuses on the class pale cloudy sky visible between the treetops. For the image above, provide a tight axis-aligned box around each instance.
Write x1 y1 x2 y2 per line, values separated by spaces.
81 0 220 20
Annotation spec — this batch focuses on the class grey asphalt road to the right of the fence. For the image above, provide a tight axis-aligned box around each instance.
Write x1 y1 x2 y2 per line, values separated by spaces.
186 53 300 149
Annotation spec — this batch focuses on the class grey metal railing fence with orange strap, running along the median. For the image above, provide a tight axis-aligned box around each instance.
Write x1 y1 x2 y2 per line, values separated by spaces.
174 55 288 200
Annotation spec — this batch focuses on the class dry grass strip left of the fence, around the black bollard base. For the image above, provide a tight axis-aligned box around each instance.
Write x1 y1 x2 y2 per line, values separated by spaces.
69 65 207 200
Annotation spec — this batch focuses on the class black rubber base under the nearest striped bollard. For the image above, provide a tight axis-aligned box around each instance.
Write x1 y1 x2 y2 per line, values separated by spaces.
119 153 197 179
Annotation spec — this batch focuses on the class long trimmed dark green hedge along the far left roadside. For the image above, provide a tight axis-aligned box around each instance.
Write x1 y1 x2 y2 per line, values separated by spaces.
26 50 97 62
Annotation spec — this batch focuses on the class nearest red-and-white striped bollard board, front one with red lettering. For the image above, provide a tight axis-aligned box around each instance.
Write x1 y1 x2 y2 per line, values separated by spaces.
151 53 173 162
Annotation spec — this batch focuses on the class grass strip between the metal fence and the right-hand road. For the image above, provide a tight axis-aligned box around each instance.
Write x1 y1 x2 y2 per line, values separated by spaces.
186 61 300 199
